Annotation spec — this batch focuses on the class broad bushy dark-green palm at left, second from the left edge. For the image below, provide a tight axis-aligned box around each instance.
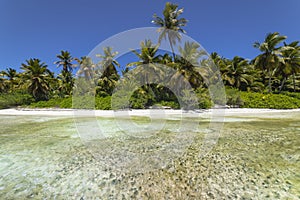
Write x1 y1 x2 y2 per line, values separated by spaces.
21 59 53 101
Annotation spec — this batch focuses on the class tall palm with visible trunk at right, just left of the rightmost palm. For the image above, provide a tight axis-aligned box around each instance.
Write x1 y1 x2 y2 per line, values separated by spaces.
253 32 287 92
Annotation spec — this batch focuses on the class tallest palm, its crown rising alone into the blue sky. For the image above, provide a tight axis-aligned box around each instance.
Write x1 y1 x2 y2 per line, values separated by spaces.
152 2 187 60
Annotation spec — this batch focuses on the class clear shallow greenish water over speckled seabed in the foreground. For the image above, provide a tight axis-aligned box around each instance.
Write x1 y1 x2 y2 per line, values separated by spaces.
0 113 300 199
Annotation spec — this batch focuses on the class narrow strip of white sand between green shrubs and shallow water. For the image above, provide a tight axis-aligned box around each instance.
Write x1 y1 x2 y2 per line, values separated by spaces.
0 108 300 118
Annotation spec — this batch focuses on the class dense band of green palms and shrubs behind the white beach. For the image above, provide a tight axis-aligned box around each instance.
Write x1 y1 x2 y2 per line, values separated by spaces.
0 3 300 109
